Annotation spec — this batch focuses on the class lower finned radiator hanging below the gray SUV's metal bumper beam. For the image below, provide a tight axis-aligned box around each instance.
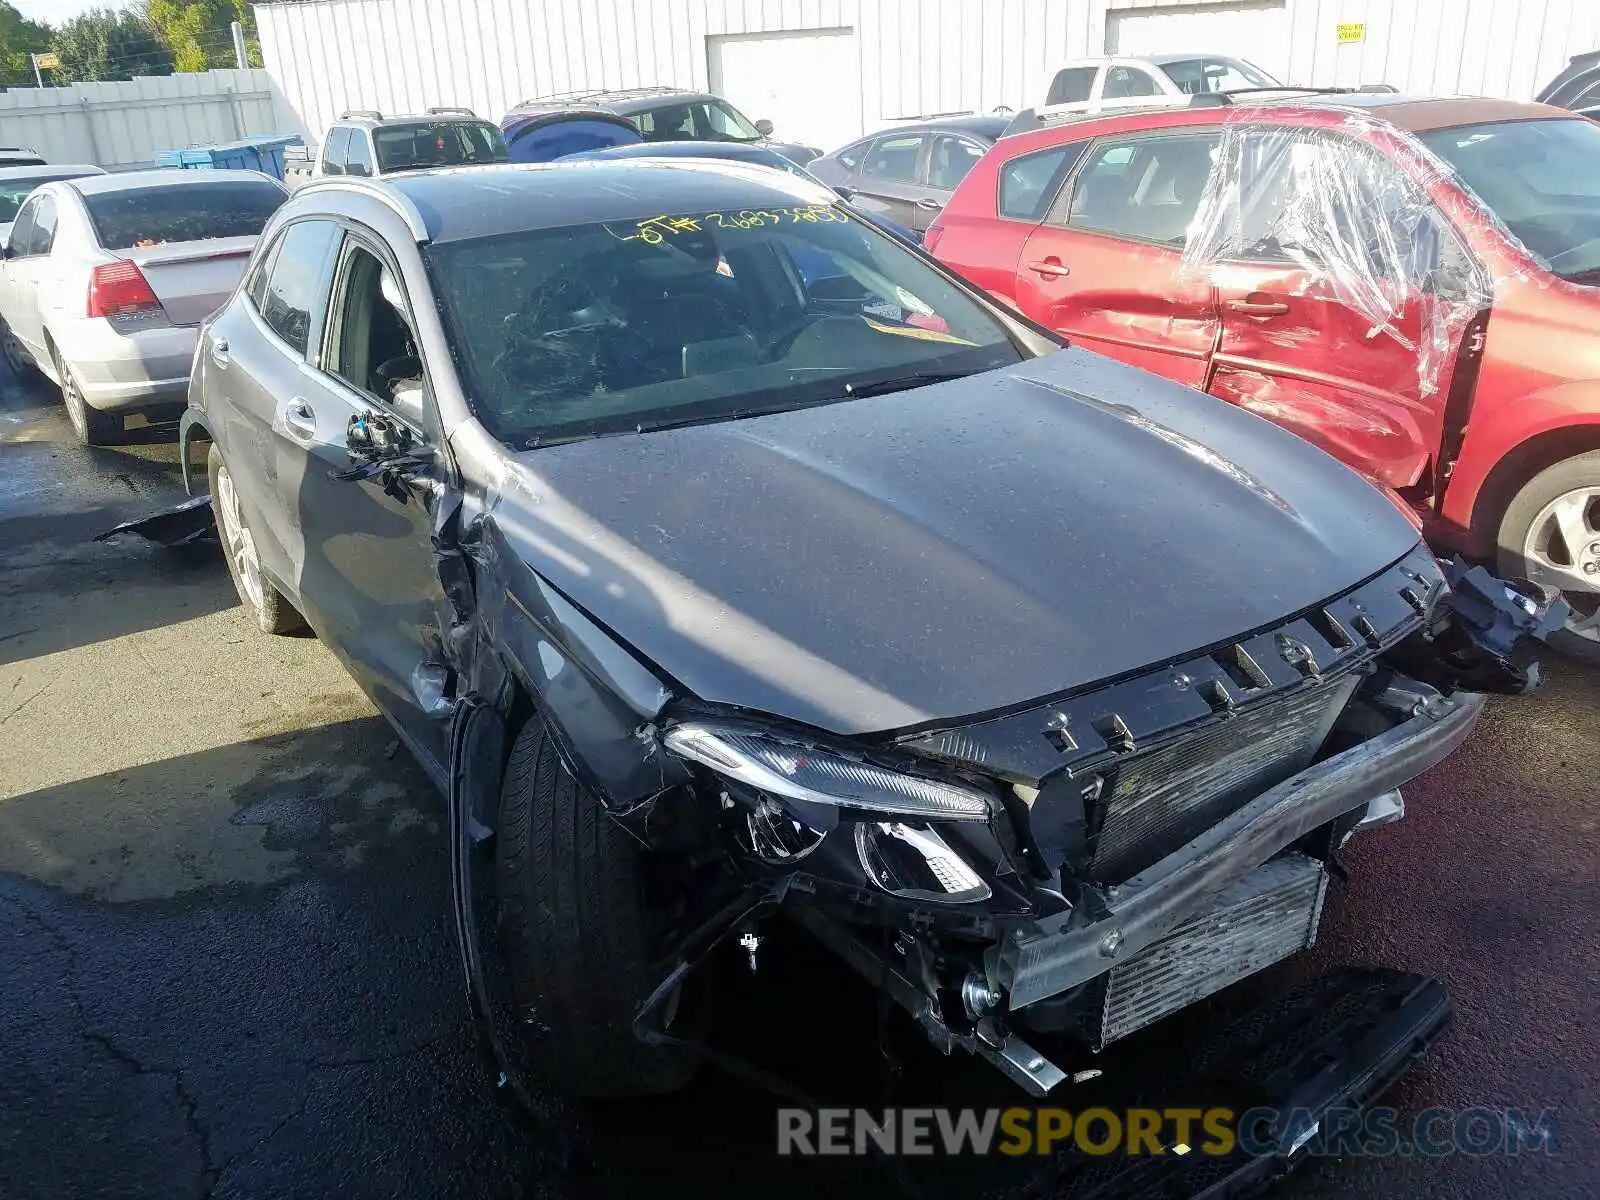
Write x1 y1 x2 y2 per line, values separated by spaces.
1099 854 1328 1046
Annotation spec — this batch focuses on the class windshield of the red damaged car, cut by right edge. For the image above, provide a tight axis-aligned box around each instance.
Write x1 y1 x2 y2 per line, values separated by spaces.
1419 117 1600 285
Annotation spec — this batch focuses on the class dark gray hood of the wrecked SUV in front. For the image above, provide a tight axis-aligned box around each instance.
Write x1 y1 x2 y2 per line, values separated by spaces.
494 349 1418 734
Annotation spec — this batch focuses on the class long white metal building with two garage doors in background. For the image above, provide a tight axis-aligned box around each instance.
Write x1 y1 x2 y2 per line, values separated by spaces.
256 0 1600 149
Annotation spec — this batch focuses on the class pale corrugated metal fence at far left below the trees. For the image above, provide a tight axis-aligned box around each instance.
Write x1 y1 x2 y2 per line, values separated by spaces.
0 70 288 170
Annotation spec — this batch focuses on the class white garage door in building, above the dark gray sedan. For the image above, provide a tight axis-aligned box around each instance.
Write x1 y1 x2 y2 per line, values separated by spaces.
706 29 861 154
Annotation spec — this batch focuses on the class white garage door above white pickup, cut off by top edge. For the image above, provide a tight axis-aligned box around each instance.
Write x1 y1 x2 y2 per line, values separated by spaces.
1106 0 1293 83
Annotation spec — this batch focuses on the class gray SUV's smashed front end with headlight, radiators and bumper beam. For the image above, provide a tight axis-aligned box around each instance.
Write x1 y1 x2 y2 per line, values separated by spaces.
652 546 1560 1094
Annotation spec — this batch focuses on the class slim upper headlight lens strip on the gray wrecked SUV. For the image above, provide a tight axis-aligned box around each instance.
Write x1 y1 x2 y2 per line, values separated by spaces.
664 722 989 821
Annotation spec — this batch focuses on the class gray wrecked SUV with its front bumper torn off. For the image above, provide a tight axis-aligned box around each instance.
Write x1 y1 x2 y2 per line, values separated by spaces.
182 160 1558 1120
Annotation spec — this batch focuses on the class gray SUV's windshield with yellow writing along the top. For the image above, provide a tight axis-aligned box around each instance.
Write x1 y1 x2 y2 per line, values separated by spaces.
427 205 1022 445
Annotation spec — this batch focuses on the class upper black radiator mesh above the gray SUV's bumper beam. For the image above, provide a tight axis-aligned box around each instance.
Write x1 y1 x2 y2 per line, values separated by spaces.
1090 677 1357 883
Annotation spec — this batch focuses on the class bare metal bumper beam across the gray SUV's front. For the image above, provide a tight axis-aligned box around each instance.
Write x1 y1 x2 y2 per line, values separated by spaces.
994 681 1485 1010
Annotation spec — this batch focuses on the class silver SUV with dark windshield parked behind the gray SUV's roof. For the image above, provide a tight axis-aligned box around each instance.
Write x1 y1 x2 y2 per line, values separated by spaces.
314 106 507 179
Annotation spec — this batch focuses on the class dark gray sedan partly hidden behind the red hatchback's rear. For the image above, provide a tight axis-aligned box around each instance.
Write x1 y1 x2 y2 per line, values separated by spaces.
806 114 1011 234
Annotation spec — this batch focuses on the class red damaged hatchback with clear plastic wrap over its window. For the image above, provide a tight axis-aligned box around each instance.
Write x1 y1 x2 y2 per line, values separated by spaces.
926 93 1600 664
